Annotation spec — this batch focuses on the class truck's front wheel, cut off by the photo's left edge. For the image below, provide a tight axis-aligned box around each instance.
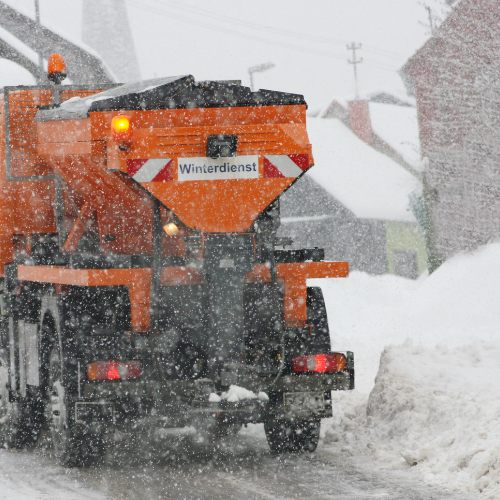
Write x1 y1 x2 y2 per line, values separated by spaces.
0 349 42 449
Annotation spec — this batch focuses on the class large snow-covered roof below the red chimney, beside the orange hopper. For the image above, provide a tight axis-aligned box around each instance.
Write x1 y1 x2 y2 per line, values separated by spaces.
307 118 421 222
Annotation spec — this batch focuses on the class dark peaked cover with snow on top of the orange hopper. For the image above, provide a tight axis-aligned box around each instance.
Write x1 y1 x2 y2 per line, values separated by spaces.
38 75 306 120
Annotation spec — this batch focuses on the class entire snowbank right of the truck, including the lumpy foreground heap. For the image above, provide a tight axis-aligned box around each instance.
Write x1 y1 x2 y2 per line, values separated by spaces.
318 243 500 499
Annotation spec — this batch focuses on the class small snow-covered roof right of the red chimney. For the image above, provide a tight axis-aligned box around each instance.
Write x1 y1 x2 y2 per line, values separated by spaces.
370 102 422 170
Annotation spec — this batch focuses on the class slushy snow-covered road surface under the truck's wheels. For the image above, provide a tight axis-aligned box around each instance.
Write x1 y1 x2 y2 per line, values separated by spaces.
0 426 475 500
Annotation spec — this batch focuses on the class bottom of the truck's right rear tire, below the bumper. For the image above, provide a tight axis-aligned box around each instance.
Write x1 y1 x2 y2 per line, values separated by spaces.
264 419 321 455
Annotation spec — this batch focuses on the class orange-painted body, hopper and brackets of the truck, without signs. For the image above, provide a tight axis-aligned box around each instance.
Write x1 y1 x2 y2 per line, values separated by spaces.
0 80 348 331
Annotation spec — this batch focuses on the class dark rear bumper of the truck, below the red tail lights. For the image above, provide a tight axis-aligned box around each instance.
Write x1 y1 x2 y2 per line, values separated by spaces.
75 369 354 428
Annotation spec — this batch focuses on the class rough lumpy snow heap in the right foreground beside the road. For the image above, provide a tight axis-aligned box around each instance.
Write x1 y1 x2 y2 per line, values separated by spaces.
367 344 500 498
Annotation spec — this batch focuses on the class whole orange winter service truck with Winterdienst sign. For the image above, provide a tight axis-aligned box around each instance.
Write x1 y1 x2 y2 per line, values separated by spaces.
0 57 354 466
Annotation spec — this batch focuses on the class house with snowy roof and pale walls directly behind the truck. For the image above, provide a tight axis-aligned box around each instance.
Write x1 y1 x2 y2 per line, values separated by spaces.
280 114 427 278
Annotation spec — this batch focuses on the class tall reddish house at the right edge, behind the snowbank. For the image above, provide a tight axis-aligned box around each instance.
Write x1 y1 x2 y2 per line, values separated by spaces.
401 0 500 270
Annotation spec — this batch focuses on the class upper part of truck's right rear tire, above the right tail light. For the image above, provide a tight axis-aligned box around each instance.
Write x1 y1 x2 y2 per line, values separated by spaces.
304 287 332 354
